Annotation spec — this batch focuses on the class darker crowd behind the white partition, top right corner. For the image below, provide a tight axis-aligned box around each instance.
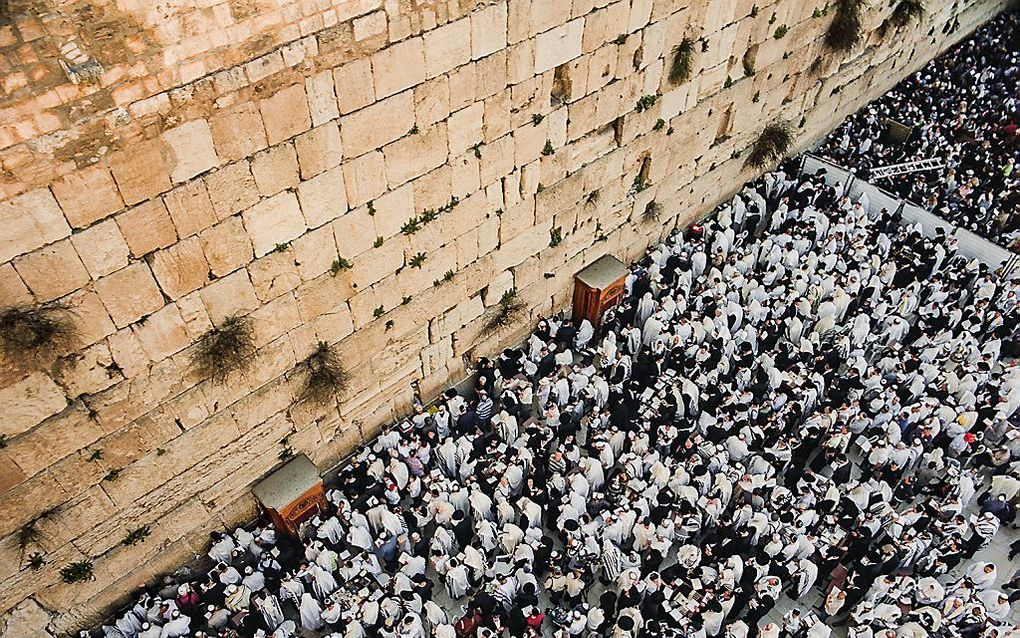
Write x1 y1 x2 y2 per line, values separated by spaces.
819 11 1020 251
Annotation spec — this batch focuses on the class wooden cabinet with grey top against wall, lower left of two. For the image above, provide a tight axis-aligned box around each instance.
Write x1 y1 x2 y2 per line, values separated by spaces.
252 454 326 537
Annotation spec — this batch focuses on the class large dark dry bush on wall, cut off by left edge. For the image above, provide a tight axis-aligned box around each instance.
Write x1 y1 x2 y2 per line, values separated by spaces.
0 303 77 364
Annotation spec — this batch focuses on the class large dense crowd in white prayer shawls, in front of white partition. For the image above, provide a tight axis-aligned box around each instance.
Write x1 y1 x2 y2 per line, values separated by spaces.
93 159 1020 638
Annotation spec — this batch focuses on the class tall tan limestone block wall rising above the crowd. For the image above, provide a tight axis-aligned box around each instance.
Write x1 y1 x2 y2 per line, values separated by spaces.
0 0 1006 638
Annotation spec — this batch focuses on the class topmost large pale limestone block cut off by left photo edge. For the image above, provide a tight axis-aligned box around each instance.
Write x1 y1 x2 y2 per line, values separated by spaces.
0 189 70 261
